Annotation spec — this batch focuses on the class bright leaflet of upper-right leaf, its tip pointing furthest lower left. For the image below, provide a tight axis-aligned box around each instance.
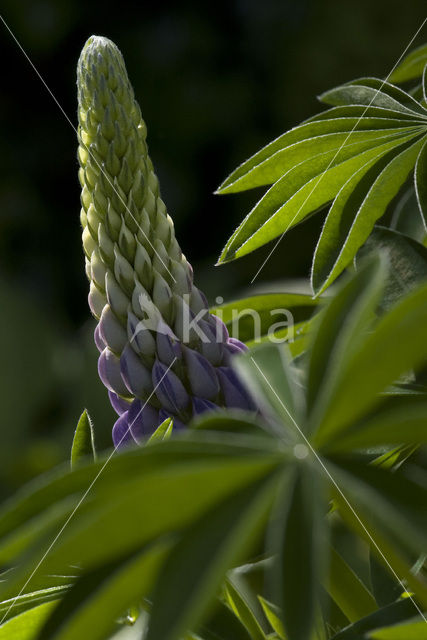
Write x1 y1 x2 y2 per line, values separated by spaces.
219 130 417 263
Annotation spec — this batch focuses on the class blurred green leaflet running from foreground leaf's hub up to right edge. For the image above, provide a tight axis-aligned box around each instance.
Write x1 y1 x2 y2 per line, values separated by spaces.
312 285 427 447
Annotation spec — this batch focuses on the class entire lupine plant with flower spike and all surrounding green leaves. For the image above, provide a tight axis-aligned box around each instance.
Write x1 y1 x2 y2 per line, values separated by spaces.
0 37 427 640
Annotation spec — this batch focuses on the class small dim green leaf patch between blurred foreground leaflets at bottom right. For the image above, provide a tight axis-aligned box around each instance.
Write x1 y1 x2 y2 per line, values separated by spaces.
325 547 377 622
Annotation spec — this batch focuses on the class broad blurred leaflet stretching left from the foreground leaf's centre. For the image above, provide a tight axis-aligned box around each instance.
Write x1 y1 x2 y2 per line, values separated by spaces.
0 438 284 597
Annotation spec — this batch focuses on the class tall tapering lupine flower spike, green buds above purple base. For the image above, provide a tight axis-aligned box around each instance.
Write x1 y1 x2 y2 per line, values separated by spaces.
78 36 254 446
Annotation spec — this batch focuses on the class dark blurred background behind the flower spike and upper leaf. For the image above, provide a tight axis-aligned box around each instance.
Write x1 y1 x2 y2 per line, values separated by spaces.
0 0 427 493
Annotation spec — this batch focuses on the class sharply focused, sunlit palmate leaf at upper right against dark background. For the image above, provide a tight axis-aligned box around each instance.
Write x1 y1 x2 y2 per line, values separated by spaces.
218 73 427 294
